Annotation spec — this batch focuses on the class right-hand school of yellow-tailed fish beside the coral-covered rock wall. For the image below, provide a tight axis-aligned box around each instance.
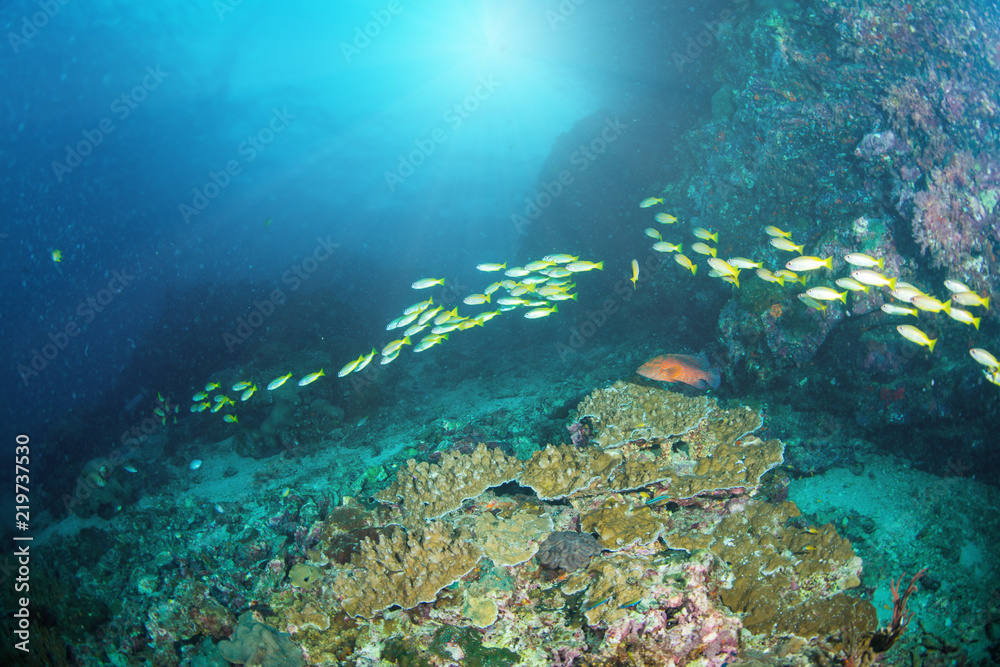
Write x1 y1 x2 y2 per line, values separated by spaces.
632 197 1000 386
